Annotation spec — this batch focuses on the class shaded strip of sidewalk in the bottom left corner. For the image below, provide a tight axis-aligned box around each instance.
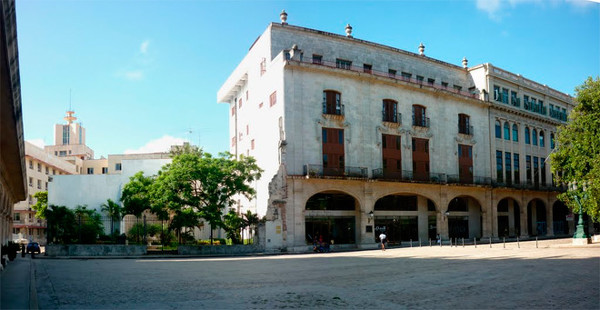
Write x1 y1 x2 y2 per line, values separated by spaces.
0 253 37 309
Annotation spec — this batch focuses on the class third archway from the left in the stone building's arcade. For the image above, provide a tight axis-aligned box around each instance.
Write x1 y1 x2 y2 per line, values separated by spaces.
444 195 483 239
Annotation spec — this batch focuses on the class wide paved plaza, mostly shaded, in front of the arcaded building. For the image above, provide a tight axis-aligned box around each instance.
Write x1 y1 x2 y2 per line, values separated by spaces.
33 239 600 309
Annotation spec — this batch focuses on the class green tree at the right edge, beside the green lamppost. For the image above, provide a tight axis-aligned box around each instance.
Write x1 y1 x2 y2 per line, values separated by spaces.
551 77 600 221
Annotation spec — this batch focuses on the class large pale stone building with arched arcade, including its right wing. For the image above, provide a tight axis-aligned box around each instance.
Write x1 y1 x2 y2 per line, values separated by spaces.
217 13 573 251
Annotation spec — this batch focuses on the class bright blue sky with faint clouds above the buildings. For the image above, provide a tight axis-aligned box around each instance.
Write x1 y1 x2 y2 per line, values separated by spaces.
16 0 600 158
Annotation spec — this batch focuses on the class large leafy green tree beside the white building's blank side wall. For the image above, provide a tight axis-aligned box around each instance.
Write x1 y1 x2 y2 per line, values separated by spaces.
152 147 261 243
